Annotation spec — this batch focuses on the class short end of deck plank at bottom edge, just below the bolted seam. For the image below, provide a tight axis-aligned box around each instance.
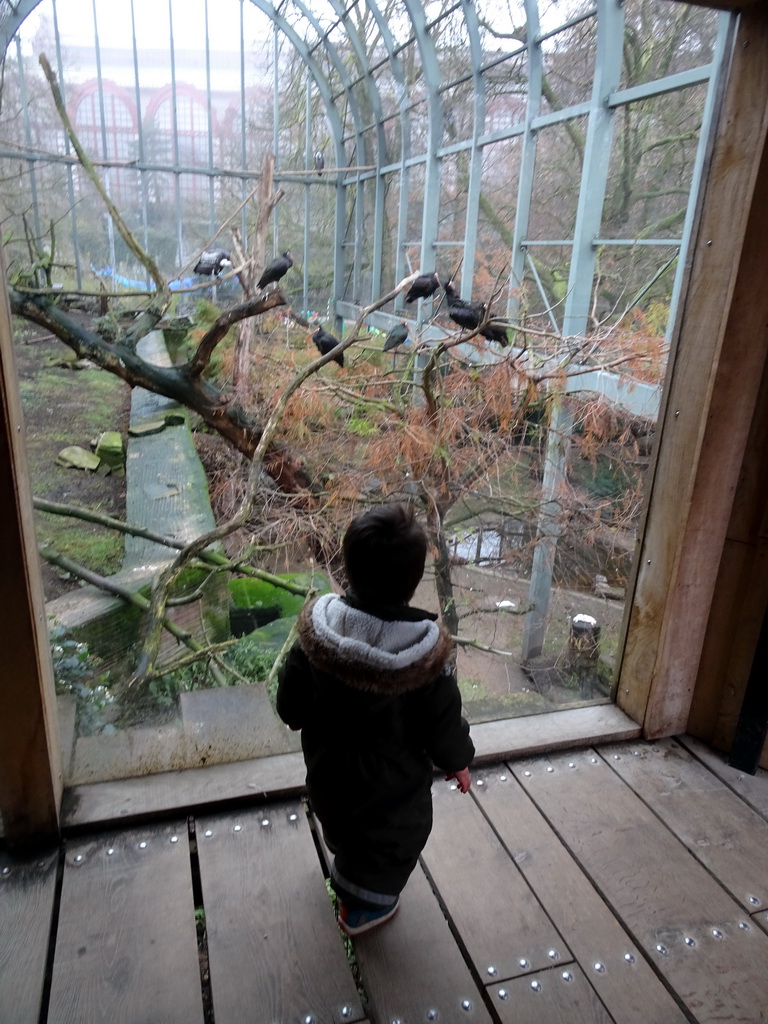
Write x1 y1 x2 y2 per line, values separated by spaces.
490 964 623 1024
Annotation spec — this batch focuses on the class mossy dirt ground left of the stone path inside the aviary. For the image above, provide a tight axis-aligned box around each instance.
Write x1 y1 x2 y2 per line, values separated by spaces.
14 327 130 601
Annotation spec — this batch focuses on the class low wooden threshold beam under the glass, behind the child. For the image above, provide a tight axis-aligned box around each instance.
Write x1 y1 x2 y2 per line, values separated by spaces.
61 703 641 833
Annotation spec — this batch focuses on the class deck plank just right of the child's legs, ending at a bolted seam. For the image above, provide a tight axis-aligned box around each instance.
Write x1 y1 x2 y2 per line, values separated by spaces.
423 782 571 984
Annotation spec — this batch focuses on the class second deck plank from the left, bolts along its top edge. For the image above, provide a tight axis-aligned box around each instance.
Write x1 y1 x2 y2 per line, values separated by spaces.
47 821 203 1024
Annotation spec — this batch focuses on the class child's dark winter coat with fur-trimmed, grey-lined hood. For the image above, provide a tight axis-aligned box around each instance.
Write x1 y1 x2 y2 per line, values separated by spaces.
278 594 474 894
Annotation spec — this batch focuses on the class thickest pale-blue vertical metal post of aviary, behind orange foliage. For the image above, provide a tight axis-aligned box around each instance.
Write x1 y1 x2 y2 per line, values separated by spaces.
522 0 624 660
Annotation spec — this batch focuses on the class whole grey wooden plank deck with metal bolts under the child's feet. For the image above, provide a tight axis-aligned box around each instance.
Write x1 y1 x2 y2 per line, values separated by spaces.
0 739 768 1024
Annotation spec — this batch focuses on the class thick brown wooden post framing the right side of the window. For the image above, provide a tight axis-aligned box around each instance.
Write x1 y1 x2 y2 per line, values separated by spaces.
617 6 768 737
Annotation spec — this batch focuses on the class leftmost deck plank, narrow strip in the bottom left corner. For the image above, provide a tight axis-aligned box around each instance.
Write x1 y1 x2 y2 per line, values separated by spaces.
0 850 58 1024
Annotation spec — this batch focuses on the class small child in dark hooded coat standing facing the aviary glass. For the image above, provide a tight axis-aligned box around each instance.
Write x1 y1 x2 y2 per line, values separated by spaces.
278 505 474 935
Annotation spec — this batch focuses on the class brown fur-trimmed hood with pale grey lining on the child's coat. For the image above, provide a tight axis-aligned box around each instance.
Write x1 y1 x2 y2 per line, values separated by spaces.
298 594 454 694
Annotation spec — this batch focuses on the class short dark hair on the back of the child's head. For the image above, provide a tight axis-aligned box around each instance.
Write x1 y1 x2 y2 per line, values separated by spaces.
341 505 427 604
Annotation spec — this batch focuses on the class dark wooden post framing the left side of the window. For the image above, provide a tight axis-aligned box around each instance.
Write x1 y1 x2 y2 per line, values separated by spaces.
0 243 62 847
